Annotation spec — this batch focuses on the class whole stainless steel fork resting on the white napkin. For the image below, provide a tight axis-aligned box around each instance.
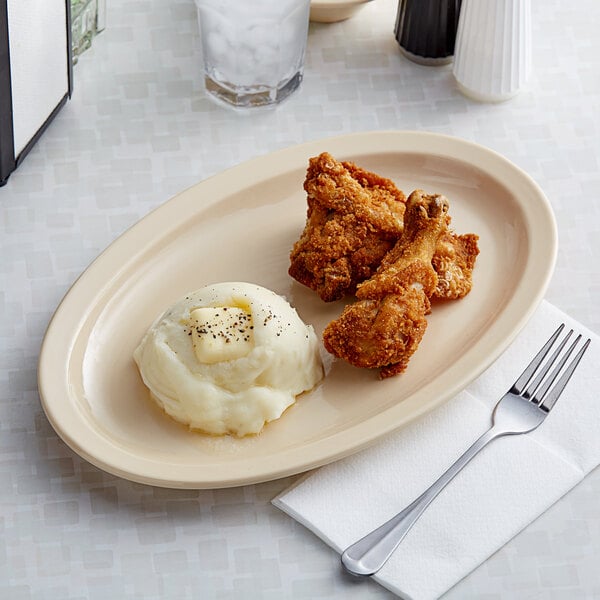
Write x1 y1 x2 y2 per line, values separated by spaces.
342 324 590 576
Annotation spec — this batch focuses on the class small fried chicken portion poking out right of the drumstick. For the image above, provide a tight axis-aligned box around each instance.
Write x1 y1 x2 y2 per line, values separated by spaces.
431 231 479 300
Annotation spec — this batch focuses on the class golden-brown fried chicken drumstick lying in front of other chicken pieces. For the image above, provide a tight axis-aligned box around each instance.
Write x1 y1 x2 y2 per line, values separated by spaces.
323 190 449 378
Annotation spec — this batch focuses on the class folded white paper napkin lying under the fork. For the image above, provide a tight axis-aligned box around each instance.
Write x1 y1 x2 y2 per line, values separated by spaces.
273 302 600 600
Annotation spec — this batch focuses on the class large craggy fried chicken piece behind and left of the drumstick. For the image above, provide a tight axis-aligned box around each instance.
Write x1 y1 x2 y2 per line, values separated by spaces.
288 152 406 302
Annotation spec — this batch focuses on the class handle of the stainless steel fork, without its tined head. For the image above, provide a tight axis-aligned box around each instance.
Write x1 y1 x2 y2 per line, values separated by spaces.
342 427 503 576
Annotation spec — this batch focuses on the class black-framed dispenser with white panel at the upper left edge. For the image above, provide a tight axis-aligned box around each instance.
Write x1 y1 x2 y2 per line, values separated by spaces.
0 0 73 186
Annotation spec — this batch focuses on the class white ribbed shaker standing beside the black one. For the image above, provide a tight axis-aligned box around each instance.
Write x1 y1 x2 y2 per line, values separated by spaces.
452 0 531 102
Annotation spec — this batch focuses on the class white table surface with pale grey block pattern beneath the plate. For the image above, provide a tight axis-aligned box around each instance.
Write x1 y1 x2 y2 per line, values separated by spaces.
0 0 600 600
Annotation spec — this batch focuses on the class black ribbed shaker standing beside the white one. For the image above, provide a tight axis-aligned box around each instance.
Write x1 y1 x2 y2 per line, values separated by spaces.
394 0 461 65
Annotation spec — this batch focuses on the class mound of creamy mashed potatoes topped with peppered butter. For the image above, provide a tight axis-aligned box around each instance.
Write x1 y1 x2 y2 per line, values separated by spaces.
134 283 323 436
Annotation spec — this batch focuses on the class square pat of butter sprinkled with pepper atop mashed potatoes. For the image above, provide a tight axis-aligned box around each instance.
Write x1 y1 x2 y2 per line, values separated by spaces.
190 306 254 364
